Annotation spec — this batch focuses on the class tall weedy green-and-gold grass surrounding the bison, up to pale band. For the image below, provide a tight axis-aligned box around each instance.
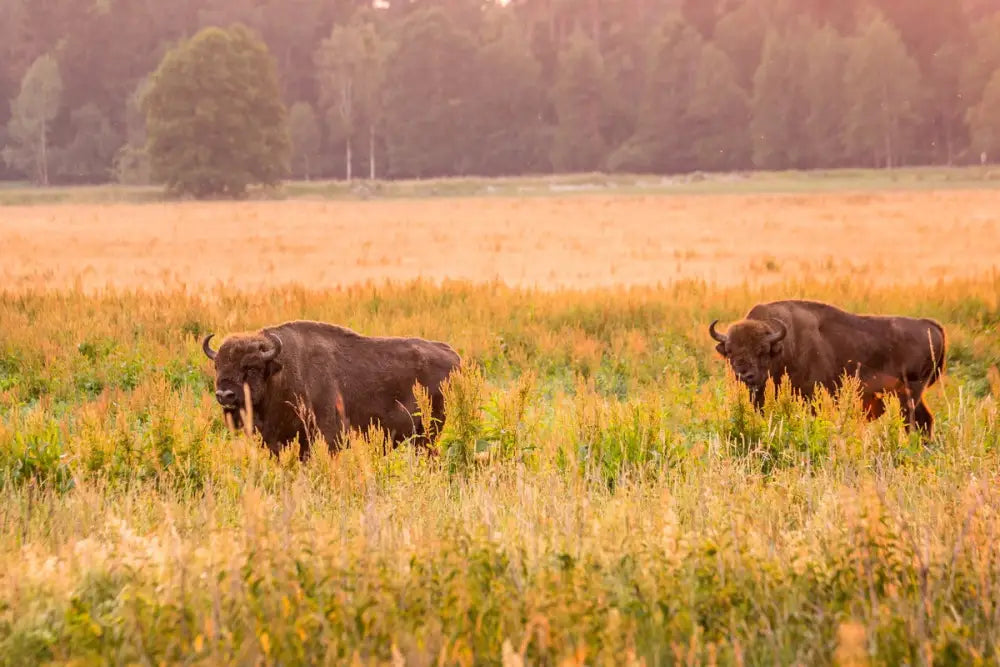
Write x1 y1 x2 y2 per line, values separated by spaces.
0 280 1000 665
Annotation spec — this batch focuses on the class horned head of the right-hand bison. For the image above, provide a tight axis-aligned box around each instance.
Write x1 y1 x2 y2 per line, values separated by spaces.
708 319 788 388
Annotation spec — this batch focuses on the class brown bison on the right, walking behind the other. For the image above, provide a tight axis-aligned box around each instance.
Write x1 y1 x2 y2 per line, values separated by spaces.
708 300 945 436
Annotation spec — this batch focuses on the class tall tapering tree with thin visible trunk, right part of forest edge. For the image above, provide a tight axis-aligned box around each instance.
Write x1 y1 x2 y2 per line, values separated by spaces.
844 14 922 168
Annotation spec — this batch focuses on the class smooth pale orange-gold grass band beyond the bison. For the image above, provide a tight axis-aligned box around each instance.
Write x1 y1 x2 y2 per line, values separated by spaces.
0 190 1000 290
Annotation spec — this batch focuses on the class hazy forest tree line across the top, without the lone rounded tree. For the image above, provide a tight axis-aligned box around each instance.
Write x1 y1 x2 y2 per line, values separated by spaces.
0 0 1000 183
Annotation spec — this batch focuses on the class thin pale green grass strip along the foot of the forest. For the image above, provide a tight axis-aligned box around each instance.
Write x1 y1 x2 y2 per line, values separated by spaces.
0 167 1000 206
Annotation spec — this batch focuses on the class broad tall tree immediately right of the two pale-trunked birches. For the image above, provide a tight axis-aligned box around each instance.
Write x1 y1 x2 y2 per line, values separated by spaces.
383 3 478 178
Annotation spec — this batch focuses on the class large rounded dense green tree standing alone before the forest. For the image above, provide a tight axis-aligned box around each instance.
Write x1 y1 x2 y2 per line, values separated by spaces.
143 25 289 197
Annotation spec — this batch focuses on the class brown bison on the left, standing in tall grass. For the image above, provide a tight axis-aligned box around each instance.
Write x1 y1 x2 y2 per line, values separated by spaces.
202 321 461 458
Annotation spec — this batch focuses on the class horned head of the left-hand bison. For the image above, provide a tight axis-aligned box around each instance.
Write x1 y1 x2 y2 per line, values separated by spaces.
201 331 281 421
